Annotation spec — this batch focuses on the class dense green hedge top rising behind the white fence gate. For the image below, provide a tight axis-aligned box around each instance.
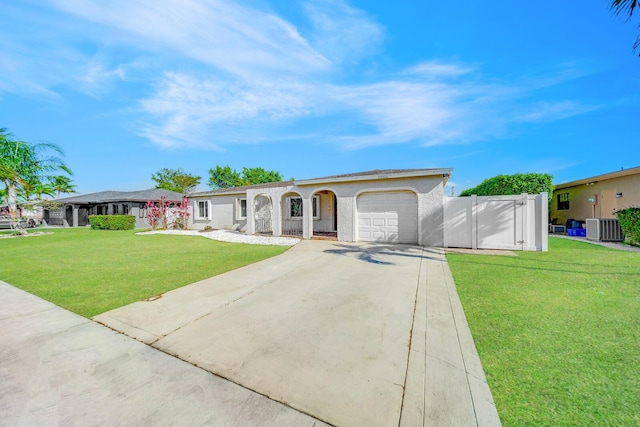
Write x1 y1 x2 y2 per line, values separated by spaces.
460 173 555 201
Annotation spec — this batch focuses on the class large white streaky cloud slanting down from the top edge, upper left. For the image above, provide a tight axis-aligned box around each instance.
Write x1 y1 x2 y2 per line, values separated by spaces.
53 0 328 76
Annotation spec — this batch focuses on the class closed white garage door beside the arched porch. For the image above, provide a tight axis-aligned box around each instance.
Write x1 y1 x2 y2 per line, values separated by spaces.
357 191 418 243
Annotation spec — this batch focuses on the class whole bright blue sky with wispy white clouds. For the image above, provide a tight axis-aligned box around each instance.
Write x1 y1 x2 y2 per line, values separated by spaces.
0 0 640 194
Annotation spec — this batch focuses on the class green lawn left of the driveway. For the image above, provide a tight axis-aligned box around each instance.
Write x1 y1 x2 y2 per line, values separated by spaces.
0 228 287 317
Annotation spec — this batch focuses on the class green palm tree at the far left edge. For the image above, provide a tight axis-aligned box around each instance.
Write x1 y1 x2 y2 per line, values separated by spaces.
0 128 71 232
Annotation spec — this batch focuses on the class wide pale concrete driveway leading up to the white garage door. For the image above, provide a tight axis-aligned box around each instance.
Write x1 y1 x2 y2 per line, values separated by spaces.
94 241 499 426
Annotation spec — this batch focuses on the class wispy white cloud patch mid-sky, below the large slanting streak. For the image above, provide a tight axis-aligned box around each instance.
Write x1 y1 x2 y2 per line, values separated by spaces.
140 73 317 149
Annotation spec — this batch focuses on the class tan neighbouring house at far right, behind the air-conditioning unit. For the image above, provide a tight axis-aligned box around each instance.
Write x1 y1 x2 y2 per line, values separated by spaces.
551 167 640 225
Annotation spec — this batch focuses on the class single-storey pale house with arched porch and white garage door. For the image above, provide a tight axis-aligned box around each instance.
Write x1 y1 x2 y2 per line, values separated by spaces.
189 169 452 246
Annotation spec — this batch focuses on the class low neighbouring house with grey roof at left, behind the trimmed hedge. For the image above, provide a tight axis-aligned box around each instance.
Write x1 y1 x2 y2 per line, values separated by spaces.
44 188 183 228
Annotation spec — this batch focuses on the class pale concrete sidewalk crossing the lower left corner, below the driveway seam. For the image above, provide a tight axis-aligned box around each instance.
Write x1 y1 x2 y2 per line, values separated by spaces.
0 282 326 427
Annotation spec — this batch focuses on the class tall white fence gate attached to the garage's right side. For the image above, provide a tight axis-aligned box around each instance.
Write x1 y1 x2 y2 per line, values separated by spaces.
444 193 549 252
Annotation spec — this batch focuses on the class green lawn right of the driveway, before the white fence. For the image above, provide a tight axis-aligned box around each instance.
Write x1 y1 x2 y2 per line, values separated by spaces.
447 237 640 426
